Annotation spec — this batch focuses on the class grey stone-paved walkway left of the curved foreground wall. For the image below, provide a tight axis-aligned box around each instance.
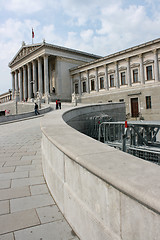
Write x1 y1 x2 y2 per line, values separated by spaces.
0 118 78 240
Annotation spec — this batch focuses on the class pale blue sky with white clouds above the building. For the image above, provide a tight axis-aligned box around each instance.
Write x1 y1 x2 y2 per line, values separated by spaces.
0 0 160 93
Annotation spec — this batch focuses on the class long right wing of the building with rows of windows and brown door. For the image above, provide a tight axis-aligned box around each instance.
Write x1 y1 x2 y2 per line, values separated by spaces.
70 39 160 120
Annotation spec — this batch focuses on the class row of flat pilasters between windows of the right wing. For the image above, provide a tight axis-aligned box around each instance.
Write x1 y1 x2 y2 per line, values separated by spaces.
71 49 160 96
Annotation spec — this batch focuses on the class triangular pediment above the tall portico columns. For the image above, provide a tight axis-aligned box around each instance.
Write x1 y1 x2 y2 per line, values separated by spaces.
9 44 42 66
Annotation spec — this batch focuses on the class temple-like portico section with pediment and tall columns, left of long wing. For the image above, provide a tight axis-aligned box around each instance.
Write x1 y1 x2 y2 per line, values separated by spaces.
9 41 100 101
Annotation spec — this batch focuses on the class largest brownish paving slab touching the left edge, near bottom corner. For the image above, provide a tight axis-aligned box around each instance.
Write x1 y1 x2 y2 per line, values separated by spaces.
0 209 40 234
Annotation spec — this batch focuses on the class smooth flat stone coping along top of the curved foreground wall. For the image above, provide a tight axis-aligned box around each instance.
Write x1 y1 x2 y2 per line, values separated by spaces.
41 107 160 213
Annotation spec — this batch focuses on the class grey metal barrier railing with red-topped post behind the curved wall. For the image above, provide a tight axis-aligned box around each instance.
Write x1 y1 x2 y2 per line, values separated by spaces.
98 122 160 164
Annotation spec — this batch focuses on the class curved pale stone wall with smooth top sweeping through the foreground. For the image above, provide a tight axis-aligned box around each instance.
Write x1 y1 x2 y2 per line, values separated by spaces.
41 105 160 240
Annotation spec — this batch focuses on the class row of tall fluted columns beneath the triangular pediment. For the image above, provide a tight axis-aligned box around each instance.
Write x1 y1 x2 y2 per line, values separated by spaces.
11 55 50 101
